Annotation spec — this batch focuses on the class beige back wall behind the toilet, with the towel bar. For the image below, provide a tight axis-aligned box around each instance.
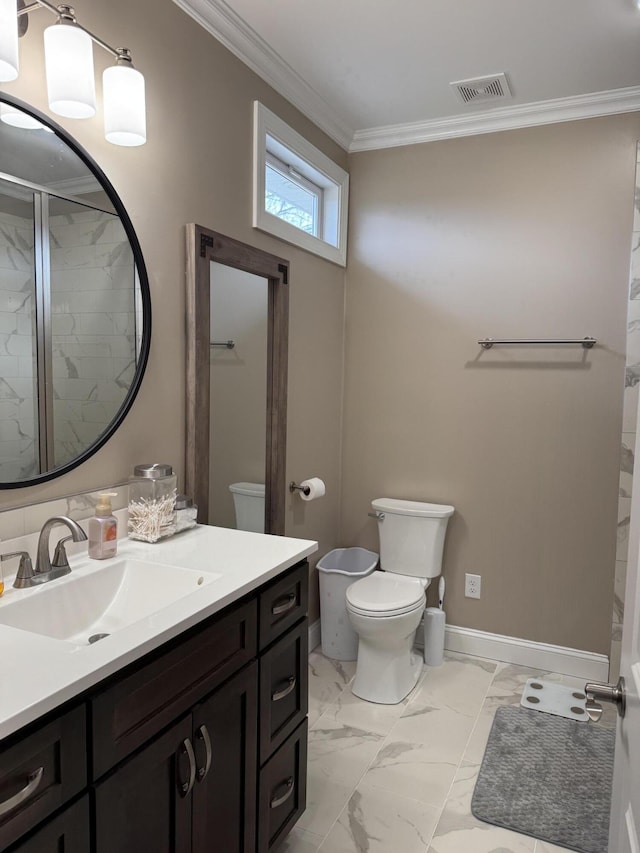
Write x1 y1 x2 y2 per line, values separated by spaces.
341 116 640 654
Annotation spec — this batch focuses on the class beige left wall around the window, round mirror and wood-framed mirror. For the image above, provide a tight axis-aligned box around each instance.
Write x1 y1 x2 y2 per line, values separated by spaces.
0 0 347 616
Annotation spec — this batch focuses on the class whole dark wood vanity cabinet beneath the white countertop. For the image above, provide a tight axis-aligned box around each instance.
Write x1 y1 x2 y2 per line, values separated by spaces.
0 561 308 853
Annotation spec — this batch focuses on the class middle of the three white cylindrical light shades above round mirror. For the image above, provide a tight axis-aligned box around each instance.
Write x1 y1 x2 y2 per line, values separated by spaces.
44 23 96 118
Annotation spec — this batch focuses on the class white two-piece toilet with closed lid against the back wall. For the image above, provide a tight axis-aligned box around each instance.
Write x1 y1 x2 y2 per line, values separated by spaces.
346 498 454 705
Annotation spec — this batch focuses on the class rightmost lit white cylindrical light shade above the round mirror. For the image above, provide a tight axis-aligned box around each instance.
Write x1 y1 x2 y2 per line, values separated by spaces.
102 64 147 146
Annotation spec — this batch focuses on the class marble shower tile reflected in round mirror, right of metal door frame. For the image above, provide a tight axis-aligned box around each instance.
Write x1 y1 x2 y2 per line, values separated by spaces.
50 206 136 465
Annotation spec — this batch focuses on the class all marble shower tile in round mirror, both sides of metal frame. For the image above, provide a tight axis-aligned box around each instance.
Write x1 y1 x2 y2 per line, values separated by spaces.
0 202 136 481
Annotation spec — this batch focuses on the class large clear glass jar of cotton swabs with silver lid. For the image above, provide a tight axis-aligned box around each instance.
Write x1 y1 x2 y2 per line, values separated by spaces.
128 462 177 542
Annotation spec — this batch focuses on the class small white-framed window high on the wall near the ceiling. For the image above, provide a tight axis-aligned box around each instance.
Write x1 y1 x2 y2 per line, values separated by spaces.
253 101 349 266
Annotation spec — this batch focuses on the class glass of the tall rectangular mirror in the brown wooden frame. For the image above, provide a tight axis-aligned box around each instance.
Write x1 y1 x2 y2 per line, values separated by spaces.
209 262 269 533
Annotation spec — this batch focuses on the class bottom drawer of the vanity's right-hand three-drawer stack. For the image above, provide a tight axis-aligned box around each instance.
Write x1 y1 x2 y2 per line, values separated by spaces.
258 720 307 853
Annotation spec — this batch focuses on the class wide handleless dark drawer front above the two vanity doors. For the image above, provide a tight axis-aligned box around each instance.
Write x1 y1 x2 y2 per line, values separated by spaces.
91 601 257 779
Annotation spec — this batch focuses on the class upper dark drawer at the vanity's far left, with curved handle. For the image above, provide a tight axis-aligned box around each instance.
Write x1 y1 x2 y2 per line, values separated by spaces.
0 705 87 850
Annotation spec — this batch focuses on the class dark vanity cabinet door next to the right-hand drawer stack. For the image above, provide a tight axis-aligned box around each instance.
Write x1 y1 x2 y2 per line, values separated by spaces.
192 662 258 853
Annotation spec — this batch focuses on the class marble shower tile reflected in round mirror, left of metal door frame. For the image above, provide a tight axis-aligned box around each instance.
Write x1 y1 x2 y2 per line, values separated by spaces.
0 211 38 481
